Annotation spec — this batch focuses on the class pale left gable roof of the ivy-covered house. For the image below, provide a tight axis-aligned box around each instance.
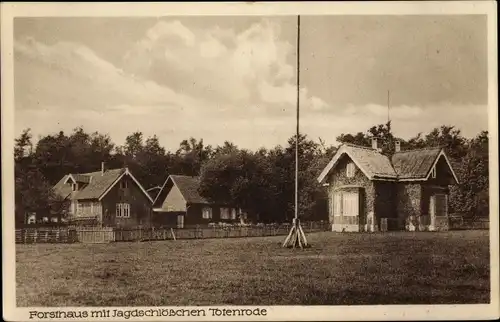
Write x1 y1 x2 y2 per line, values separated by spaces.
318 144 397 183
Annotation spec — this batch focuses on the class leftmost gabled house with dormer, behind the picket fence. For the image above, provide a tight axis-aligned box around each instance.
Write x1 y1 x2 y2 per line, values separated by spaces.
54 164 153 227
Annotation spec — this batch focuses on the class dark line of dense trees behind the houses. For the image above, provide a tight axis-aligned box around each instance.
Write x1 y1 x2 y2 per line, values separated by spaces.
14 122 489 222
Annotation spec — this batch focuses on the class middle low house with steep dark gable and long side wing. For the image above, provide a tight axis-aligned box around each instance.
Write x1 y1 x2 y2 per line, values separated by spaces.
153 175 241 228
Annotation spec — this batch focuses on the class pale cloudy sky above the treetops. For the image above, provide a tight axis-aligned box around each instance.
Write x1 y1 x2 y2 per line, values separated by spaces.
14 15 488 150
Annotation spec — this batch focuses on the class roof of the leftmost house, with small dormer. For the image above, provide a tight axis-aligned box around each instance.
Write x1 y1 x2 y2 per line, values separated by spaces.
53 168 153 201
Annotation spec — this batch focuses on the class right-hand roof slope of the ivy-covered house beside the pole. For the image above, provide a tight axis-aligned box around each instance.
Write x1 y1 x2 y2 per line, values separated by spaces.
392 148 441 179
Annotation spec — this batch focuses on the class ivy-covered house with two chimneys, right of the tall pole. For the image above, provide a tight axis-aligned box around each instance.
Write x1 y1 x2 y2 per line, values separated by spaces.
318 139 458 231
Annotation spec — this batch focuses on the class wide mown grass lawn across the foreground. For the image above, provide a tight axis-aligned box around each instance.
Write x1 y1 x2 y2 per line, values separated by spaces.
16 231 490 306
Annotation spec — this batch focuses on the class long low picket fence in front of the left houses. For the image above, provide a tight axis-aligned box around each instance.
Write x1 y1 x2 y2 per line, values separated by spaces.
16 222 329 244
